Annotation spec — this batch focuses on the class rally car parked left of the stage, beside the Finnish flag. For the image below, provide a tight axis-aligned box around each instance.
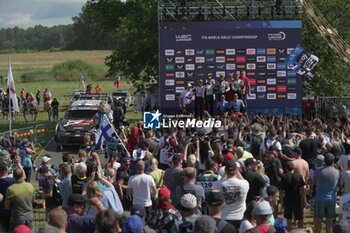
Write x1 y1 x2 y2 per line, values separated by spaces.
55 100 110 150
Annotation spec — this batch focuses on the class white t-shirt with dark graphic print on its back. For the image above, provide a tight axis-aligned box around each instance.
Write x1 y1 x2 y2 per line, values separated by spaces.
213 178 249 220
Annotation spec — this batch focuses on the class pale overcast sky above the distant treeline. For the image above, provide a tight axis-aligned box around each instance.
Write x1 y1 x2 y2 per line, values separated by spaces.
0 0 87 29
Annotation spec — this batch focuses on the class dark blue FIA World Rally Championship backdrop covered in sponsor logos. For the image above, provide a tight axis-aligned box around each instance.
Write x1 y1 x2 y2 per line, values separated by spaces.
159 20 302 115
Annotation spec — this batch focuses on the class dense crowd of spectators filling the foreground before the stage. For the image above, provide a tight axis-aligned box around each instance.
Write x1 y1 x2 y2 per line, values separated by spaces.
0 101 350 233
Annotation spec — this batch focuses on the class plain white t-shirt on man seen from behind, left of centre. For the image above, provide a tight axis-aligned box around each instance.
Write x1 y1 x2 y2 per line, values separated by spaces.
128 173 156 207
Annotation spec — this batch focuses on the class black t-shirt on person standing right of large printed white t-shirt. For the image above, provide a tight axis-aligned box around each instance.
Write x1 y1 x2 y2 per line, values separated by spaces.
281 173 305 205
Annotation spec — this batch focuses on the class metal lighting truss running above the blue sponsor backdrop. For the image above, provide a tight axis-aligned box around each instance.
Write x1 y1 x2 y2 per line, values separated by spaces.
158 0 302 21
